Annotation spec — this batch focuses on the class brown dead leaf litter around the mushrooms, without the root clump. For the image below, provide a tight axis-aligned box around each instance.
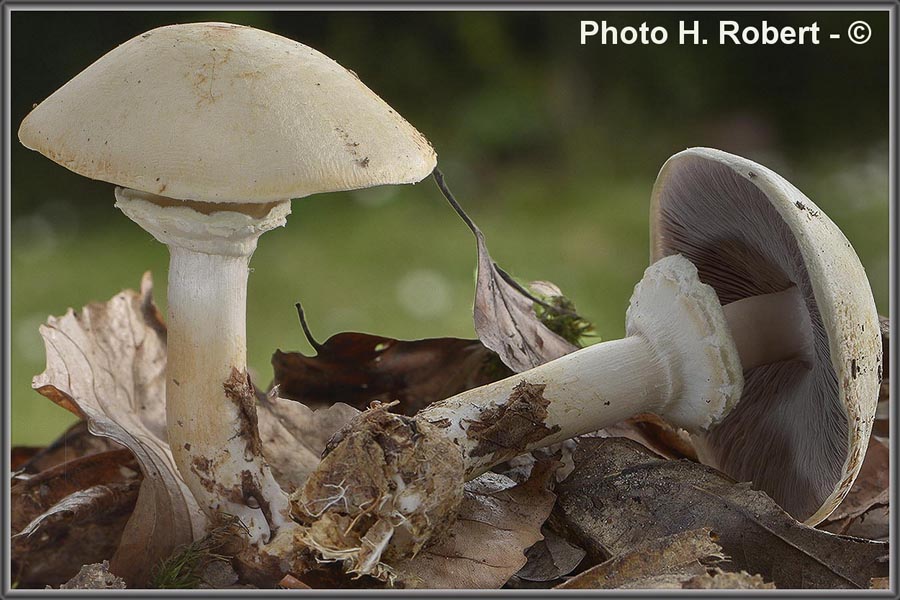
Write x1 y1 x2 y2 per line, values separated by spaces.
12 171 889 589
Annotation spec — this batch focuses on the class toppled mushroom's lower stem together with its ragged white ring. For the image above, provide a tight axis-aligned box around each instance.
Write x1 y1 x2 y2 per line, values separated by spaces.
419 255 743 477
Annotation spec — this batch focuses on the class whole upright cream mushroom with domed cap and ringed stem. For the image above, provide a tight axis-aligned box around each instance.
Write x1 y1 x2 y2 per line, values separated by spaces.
19 23 436 544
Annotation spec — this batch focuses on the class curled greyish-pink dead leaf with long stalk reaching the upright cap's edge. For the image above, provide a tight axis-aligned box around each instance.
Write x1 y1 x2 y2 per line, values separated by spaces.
433 169 578 373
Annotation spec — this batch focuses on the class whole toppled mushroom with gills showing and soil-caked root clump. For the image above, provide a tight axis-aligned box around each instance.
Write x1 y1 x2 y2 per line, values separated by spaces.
292 149 881 576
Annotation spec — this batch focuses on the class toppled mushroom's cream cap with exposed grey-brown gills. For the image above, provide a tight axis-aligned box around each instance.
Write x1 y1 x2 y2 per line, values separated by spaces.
651 148 882 524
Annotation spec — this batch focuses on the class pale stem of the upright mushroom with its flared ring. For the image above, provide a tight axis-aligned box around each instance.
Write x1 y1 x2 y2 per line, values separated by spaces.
116 188 292 545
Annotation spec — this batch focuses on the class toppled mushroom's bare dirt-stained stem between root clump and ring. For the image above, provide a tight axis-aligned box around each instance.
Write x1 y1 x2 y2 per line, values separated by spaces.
418 335 673 479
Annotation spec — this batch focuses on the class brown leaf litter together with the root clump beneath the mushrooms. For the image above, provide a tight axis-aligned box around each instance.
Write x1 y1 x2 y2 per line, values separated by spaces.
17 278 890 589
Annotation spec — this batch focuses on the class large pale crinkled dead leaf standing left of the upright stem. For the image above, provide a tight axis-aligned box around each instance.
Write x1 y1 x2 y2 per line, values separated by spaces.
32 273 205 586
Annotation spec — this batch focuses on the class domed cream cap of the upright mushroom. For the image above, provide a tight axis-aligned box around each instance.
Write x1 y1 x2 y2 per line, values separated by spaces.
19 23 436 203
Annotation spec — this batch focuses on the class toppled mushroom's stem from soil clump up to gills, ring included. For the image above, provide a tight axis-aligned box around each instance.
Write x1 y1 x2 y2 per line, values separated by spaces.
419 259 812 477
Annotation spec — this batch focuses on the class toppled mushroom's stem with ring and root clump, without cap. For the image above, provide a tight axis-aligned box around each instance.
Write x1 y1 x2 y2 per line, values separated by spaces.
292 255 744 575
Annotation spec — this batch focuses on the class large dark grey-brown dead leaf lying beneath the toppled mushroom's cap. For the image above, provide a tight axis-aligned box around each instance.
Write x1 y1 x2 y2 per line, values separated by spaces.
554 438 888 588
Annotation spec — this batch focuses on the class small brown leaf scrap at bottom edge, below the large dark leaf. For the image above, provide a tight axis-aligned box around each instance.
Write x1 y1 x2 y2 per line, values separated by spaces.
556 528 725 590
